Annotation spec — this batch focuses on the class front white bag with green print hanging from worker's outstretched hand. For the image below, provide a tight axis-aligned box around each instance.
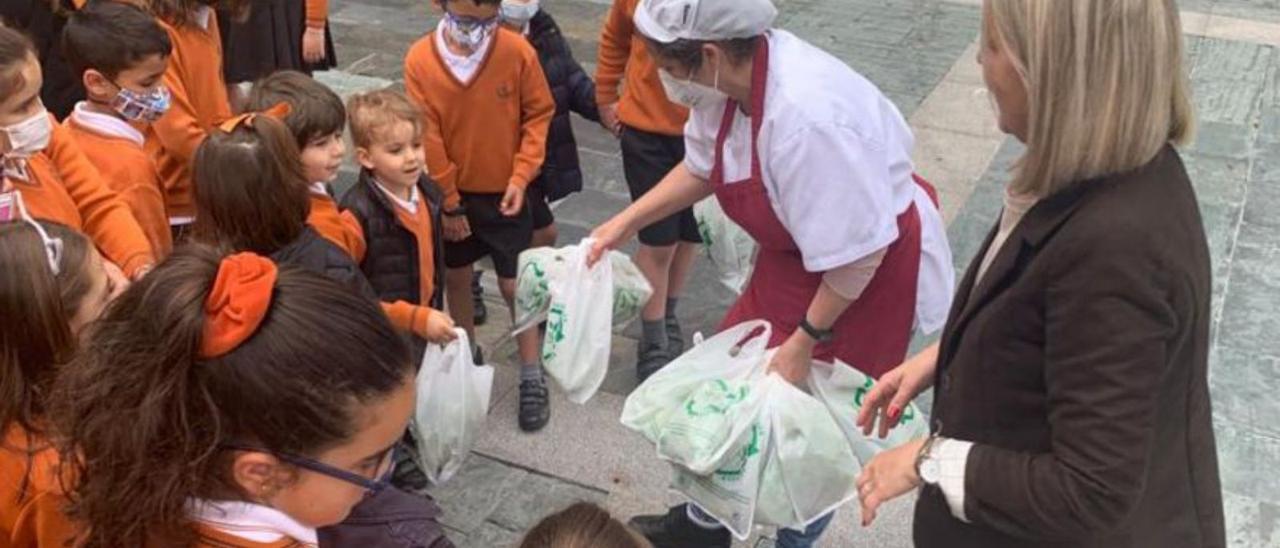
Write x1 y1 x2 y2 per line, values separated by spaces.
543 239 613 403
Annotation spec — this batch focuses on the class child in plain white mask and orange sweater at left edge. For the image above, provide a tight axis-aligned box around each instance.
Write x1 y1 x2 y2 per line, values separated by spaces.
0 26 155 278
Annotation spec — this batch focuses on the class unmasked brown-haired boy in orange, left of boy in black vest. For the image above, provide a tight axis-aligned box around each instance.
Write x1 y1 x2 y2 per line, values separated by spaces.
244 70 365 262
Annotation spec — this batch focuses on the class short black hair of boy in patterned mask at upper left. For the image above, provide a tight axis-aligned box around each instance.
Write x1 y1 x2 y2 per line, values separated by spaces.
63 0 173 79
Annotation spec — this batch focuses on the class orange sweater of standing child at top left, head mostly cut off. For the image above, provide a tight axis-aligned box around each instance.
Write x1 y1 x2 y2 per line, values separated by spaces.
147 15 232 218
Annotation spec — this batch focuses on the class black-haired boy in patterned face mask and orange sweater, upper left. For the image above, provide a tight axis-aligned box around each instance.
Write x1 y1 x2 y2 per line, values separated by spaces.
63 1 173 259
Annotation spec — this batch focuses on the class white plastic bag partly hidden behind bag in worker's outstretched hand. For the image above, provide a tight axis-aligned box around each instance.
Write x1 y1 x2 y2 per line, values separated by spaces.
512 246 653 333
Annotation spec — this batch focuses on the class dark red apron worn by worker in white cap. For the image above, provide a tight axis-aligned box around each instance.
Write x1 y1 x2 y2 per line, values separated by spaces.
710 40 937 378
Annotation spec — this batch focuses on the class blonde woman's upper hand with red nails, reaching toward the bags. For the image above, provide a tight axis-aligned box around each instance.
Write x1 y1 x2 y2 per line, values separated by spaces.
858 344 938 438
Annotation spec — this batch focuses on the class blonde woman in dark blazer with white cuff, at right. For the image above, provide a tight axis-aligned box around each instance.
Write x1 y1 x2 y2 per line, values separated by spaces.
858 0 1225 548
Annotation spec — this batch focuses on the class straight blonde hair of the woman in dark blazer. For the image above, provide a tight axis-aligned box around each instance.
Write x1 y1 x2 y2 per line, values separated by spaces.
983 0 1194 196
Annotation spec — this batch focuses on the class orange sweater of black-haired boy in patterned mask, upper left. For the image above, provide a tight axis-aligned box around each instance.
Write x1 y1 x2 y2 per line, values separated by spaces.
63 114 173 259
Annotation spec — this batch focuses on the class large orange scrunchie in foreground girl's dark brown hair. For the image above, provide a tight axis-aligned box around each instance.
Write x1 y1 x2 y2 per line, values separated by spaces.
200 254 276 360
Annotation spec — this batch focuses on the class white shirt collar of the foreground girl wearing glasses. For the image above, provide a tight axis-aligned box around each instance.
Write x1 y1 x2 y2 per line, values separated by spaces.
187 499 320 545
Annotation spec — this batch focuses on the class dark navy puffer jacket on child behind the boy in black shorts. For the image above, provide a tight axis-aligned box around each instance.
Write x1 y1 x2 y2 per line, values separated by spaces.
529 10 600 201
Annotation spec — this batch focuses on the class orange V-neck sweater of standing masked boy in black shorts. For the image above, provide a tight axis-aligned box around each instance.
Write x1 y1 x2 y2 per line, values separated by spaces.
404 28 556 209
